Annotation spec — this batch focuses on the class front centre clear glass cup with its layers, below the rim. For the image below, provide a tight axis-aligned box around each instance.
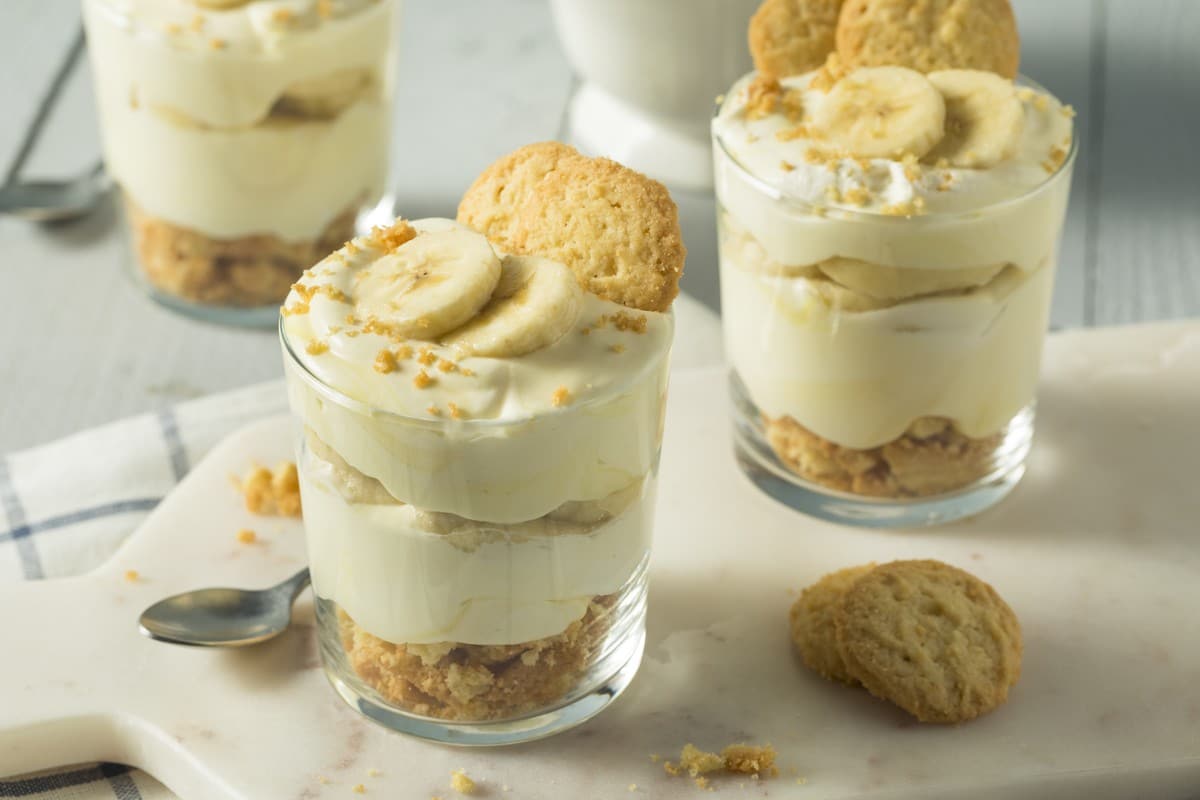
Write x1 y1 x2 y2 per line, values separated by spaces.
280 314 666 745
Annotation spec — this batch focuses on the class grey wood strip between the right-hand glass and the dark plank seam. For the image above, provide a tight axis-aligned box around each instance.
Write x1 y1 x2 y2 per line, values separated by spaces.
1013 0 1094 327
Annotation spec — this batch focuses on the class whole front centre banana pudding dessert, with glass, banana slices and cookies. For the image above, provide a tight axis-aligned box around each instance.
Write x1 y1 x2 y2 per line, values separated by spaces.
280 143 684 745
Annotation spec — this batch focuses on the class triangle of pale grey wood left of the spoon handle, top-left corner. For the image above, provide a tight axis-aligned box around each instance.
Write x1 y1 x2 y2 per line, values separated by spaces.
0 0 79 175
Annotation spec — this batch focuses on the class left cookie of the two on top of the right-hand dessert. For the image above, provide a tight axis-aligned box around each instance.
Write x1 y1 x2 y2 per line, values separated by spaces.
749 0 842 78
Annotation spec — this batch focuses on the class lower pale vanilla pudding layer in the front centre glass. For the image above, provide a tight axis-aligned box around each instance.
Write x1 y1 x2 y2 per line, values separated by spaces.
300 432 654 645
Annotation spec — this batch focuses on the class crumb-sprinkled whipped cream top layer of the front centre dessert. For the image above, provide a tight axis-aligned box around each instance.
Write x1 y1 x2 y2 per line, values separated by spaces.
282 219 673 523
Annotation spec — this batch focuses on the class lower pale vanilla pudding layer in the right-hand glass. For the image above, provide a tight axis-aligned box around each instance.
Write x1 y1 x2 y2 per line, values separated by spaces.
721 211 1054 449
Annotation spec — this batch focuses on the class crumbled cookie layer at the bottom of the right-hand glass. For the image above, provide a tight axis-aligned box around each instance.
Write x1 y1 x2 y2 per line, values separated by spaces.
763 416 1004 498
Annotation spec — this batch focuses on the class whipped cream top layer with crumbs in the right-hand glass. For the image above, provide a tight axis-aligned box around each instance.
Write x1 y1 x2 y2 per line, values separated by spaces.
713 73 1073 271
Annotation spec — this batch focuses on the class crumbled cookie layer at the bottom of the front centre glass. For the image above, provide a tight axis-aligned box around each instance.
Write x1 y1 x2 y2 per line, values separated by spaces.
338 595 617 722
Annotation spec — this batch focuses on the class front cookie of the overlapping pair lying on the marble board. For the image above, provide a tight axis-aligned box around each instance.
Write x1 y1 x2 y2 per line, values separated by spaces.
835 561 1022 722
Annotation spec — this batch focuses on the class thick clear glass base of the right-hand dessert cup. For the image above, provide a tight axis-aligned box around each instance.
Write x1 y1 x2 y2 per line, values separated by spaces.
730 372 1033 528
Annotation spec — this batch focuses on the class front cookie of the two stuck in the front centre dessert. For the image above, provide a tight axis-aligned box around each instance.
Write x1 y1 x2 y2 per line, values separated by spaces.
515 157 688 311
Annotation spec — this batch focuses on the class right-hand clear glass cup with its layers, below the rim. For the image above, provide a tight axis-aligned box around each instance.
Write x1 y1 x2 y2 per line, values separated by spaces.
713 73 1075 528
